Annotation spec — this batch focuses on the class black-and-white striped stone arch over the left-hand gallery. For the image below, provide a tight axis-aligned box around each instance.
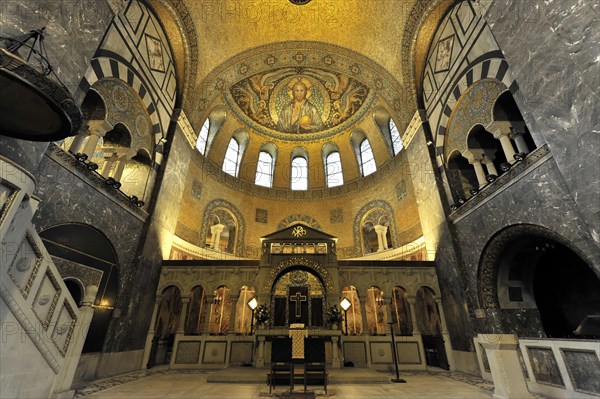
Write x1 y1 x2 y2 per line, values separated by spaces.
74 57 166 169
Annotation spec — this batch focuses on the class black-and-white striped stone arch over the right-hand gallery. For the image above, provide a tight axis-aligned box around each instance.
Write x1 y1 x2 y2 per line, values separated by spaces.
435 52 519 170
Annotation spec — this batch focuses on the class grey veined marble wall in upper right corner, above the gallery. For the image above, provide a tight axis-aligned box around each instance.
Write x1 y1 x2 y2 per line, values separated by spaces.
485 0 600 245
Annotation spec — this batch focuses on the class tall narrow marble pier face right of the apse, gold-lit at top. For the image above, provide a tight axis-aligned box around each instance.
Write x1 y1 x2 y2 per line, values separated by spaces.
406 129 474 351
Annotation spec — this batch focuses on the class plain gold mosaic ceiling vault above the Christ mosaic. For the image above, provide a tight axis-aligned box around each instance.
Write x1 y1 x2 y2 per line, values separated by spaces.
149 0 452 136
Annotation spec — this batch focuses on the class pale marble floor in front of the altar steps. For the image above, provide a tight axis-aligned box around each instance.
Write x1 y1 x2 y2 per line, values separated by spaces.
75 369 493 399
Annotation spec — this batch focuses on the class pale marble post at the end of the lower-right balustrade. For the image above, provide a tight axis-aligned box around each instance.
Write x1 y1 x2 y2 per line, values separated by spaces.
477 334 534 399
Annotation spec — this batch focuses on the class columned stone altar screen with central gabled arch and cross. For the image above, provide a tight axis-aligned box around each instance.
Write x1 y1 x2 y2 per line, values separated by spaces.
142 224 452 376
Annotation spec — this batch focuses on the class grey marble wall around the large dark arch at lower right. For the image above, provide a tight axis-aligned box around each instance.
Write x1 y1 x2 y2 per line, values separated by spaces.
454 158 600 336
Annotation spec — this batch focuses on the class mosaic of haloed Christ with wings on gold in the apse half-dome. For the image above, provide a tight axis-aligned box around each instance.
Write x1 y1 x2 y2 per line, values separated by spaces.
230 68 369 134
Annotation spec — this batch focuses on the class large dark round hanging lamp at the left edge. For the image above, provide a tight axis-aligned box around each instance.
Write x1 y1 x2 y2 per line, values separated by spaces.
0 28 83 141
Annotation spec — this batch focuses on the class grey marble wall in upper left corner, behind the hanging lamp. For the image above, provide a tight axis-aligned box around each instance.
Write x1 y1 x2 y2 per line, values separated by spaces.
0 0 114 94
